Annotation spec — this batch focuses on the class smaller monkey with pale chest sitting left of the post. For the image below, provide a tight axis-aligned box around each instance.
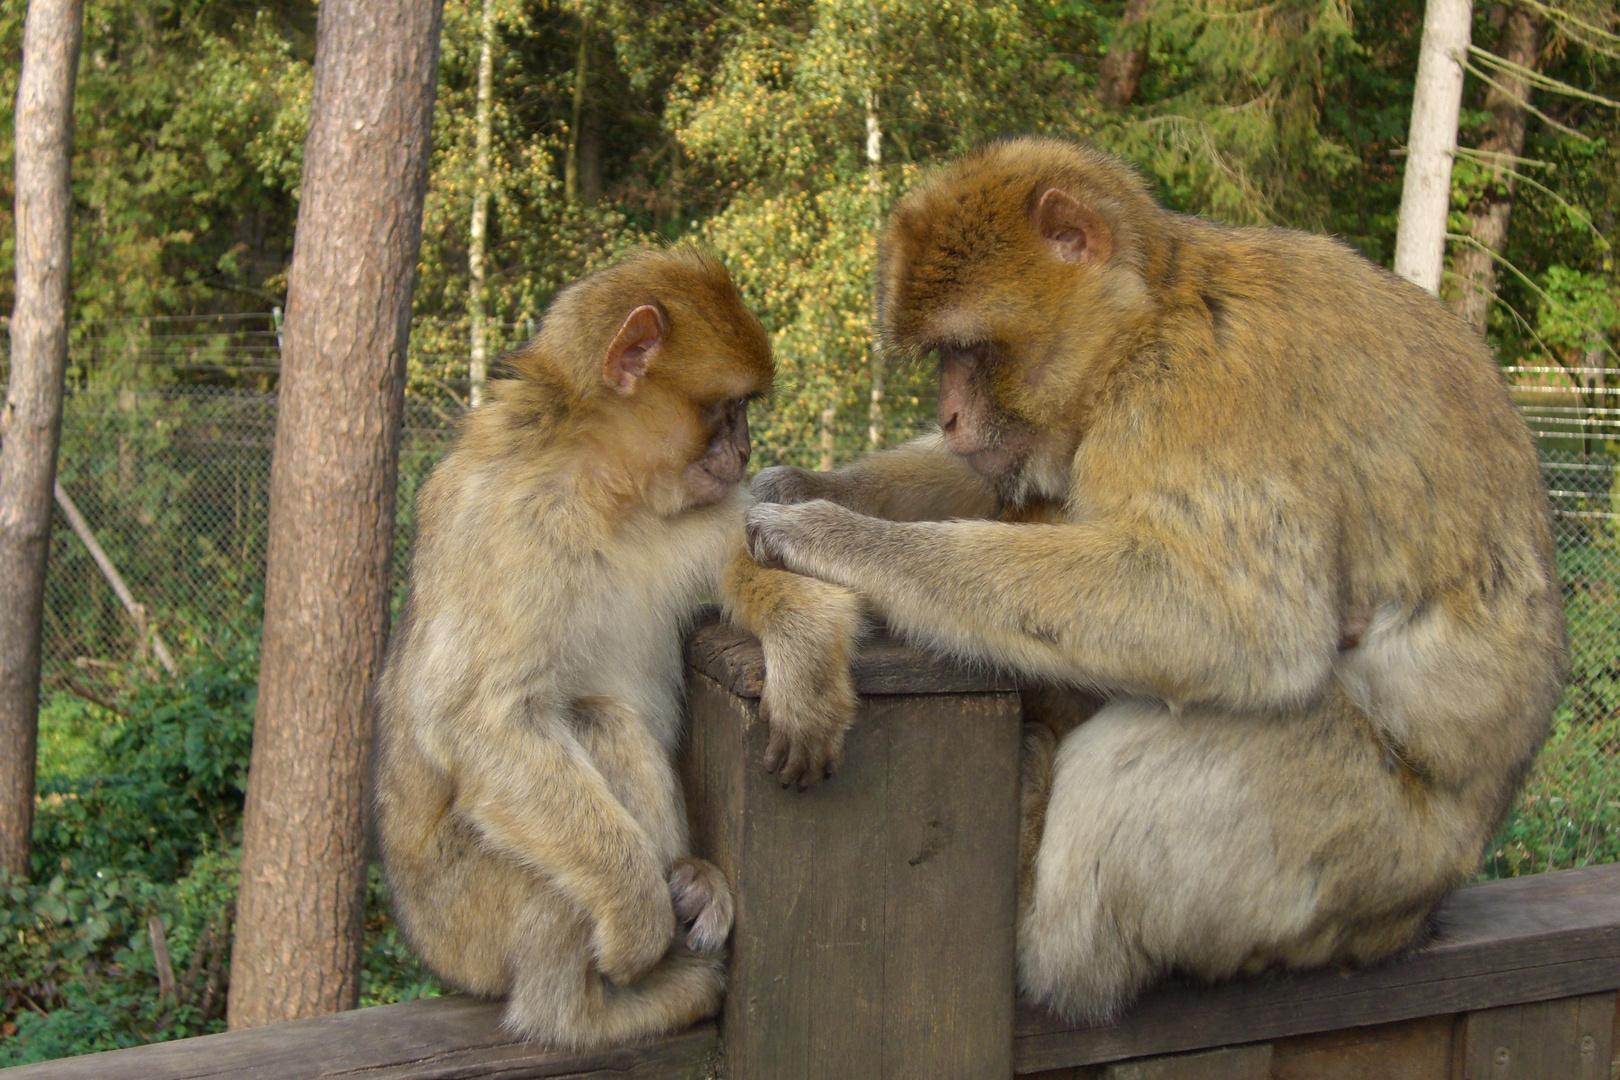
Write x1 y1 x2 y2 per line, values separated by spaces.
374 248 862 1048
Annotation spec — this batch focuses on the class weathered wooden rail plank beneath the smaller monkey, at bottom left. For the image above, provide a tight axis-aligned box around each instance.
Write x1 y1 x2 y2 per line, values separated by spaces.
0 996 719 1080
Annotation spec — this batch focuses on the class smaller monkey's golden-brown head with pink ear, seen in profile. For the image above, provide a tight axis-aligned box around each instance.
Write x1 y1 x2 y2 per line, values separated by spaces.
509 246 774 513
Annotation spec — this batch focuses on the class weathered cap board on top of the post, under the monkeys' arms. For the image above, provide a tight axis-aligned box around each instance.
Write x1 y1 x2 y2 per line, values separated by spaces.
687 607 1014 698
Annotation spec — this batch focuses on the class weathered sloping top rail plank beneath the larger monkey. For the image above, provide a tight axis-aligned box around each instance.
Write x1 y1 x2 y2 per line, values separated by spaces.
1014 865 1620 1074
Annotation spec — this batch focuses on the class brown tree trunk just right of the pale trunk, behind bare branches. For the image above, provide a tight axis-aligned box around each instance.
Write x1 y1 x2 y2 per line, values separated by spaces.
1452 8 1544 334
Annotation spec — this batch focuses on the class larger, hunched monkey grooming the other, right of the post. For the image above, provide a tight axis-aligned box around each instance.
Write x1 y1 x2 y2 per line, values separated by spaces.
748 139 1565 1020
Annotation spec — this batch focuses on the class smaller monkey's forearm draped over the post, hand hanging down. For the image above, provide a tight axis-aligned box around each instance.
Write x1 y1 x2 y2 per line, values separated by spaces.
721 551 862 789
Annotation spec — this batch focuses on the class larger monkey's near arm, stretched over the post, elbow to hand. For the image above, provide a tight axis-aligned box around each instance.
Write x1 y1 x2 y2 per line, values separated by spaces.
747 502 1338 711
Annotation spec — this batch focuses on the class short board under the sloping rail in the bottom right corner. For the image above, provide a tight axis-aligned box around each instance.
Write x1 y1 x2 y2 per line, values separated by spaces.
1463 993 1615 1080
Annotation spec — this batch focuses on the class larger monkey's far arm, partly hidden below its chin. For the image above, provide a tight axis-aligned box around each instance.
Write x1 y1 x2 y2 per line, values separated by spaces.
752 434 996 521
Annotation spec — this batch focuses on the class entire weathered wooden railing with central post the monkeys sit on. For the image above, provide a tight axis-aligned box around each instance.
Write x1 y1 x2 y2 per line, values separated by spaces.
5 619 1620 1080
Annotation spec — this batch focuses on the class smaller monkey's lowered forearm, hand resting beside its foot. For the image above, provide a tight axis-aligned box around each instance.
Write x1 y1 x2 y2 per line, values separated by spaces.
457 719 676 984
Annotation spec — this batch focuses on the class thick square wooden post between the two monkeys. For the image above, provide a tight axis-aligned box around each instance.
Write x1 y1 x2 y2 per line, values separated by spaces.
685 619 1021 1080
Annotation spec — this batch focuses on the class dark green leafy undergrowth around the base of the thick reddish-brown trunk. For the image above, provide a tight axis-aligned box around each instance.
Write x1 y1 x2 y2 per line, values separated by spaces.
0 630 442 1067
